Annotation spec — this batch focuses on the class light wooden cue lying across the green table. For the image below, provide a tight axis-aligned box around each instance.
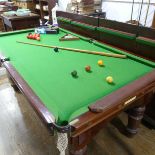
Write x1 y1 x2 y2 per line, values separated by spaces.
17 41 127 58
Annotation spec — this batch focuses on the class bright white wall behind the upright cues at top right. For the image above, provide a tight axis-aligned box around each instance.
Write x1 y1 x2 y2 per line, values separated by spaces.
102 0 155 27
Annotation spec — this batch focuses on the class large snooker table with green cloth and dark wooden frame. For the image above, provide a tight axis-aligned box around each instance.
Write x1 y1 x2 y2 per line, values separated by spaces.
0 28 155 155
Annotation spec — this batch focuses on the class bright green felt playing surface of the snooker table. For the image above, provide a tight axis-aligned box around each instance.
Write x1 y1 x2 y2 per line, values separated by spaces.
0 30 155 124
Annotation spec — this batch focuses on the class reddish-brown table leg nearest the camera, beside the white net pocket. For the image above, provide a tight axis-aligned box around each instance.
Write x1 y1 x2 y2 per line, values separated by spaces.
70 132 91 155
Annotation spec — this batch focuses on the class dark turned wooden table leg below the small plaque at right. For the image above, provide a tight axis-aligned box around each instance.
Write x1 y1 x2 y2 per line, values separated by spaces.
126 106 145 137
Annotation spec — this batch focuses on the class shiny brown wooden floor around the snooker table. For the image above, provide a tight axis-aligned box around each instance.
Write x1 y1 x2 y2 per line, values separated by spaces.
0 68 155 155
